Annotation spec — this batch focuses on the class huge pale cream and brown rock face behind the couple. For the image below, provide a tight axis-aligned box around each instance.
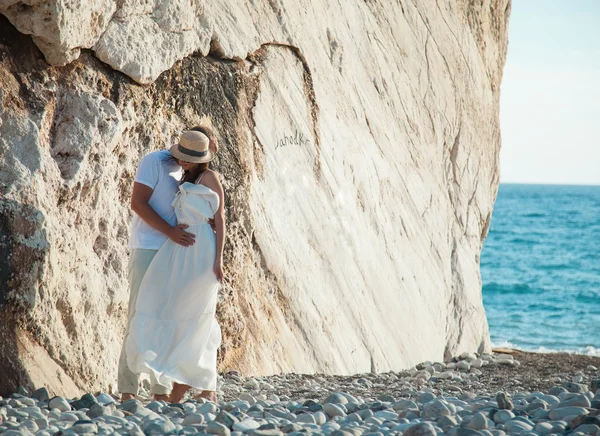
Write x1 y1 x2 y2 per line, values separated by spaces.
0 0 510 395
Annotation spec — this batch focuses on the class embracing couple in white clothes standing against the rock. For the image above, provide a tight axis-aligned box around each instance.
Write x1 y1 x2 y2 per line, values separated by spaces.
118 127 225 403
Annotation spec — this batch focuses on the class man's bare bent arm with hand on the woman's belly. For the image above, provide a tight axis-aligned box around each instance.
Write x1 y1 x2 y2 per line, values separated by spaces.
131 182 195 247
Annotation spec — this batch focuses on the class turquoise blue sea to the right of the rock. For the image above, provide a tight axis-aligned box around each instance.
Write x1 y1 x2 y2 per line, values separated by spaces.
480 184 600 356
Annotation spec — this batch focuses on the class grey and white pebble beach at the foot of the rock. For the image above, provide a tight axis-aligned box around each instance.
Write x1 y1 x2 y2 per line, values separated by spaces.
0 350 600 436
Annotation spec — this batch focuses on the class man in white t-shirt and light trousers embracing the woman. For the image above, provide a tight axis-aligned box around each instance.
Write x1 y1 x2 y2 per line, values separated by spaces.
118 126 217 401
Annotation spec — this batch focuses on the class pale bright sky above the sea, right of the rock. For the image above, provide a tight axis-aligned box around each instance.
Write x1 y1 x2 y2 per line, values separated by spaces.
500 0 600 185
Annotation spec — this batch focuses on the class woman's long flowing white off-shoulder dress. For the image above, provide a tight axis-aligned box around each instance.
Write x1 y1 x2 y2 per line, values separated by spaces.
126 182 221 391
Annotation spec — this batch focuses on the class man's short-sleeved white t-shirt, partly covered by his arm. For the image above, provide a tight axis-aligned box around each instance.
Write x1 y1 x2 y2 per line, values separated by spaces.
129 150 183 250
